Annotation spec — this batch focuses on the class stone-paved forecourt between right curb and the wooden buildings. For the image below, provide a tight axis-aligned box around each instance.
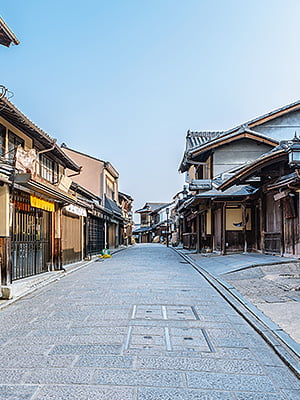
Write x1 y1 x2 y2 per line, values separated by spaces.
189 252 300 344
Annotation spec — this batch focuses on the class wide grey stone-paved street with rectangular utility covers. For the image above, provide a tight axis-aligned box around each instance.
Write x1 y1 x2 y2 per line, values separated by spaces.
0 245 300 400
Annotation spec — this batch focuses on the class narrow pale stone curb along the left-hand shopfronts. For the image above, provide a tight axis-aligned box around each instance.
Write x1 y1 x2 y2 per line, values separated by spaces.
0 247 127 311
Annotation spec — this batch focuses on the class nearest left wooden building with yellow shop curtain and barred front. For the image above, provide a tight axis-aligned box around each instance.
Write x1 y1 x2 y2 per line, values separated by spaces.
0 98 80 297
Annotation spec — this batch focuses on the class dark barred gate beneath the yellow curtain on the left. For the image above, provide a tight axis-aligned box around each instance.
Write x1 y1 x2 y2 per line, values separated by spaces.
12 194 51 280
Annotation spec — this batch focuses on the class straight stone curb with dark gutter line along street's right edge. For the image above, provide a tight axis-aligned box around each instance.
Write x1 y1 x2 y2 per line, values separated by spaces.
173 249 300 378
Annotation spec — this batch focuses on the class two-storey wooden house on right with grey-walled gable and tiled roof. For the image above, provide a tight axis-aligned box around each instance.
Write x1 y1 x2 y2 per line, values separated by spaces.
178 127 278 254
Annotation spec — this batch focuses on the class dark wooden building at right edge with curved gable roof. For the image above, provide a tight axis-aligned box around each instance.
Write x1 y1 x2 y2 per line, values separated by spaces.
220 138 300 257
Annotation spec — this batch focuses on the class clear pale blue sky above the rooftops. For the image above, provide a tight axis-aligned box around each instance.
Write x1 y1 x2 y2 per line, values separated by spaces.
0 0 300 216
